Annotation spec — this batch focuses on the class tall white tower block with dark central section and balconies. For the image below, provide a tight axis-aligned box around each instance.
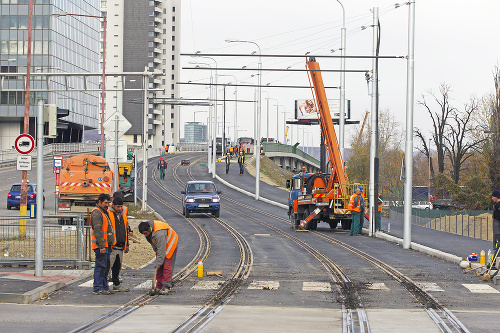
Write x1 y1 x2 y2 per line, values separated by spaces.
101 0 181 147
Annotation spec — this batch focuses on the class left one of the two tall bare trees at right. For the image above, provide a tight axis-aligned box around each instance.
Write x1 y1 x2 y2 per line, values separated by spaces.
418 83 455 173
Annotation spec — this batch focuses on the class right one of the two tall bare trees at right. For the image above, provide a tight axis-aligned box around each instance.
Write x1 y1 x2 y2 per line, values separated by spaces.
444 98 483 184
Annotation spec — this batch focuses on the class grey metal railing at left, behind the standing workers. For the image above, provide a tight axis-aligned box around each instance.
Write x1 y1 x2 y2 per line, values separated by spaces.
0 215 90 267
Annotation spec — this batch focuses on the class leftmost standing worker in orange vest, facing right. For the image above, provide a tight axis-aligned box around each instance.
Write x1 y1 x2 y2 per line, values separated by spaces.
90 193 115 295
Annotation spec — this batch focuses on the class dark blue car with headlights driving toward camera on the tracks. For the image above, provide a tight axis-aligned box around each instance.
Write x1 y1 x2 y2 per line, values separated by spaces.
181 181 222 217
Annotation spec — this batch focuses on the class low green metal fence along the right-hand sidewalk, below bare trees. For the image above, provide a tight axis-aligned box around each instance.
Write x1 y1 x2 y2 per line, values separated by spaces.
389 206 493 241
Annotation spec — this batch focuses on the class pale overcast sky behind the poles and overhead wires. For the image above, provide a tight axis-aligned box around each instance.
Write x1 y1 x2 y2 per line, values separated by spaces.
180 0 500 145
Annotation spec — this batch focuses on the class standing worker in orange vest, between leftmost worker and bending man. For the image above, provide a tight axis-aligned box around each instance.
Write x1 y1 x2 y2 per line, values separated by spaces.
108 196 129 292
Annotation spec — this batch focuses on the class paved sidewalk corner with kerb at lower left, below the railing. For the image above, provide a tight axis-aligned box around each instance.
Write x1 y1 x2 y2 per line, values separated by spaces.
0 268 93 304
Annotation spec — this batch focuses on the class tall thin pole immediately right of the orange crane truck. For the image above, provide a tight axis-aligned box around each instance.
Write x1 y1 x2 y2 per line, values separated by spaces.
369 7 378 236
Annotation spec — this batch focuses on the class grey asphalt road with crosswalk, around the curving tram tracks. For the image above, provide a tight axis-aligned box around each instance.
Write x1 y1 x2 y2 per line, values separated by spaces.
0 153 500 332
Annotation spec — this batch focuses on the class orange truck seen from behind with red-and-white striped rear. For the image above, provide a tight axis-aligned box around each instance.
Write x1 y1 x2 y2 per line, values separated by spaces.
57 154 115 214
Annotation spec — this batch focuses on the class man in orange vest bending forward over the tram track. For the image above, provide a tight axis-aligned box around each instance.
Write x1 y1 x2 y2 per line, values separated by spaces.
139 220 179 295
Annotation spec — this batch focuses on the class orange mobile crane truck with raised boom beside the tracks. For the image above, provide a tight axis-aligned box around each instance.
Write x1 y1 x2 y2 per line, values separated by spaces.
287 58 366 230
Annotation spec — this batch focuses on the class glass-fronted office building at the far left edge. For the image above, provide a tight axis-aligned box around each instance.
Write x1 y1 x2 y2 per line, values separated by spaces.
0 0 100 149
